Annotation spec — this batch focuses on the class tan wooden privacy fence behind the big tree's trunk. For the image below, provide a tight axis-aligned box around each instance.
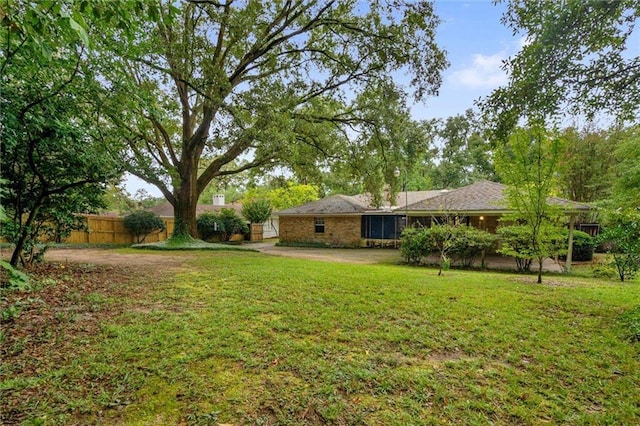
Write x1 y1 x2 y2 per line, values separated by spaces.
64 215 175 244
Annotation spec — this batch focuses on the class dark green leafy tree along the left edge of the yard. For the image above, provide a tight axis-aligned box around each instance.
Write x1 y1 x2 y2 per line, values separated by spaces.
0 0 146 266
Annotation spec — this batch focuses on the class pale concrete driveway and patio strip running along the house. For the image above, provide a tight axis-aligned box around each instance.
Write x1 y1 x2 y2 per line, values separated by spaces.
246 242 562 272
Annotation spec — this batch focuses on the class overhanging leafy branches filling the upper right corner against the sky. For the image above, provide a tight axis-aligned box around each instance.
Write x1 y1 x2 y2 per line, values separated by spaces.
484 0 640 136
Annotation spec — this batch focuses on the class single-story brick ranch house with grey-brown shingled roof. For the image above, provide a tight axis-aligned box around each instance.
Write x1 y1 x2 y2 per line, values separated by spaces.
278 180 590 247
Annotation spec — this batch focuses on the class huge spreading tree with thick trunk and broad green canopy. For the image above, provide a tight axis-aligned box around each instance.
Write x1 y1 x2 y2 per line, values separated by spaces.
100 0 446 235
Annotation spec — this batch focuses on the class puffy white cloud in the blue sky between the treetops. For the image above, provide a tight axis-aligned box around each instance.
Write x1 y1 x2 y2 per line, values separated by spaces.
449 51 507 89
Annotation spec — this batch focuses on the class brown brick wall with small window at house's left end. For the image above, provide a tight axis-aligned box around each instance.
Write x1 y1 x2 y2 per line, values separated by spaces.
280 216 361 247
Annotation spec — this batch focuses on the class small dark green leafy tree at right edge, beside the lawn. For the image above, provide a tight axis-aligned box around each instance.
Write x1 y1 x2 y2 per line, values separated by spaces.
598 210 640 282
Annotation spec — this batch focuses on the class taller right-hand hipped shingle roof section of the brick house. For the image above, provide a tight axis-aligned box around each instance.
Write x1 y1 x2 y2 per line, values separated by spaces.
407 180 590 213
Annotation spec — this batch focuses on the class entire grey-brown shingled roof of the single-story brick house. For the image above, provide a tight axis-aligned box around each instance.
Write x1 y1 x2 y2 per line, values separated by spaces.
278 180 590 216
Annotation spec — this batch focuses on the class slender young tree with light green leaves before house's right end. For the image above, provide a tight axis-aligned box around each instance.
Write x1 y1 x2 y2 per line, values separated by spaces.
496 126 562 283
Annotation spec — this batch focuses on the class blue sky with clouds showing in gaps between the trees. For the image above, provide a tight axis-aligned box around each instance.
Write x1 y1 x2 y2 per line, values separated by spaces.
125 0 522 197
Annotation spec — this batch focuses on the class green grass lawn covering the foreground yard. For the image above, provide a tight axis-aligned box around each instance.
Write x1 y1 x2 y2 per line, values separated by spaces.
0 251 640 425
